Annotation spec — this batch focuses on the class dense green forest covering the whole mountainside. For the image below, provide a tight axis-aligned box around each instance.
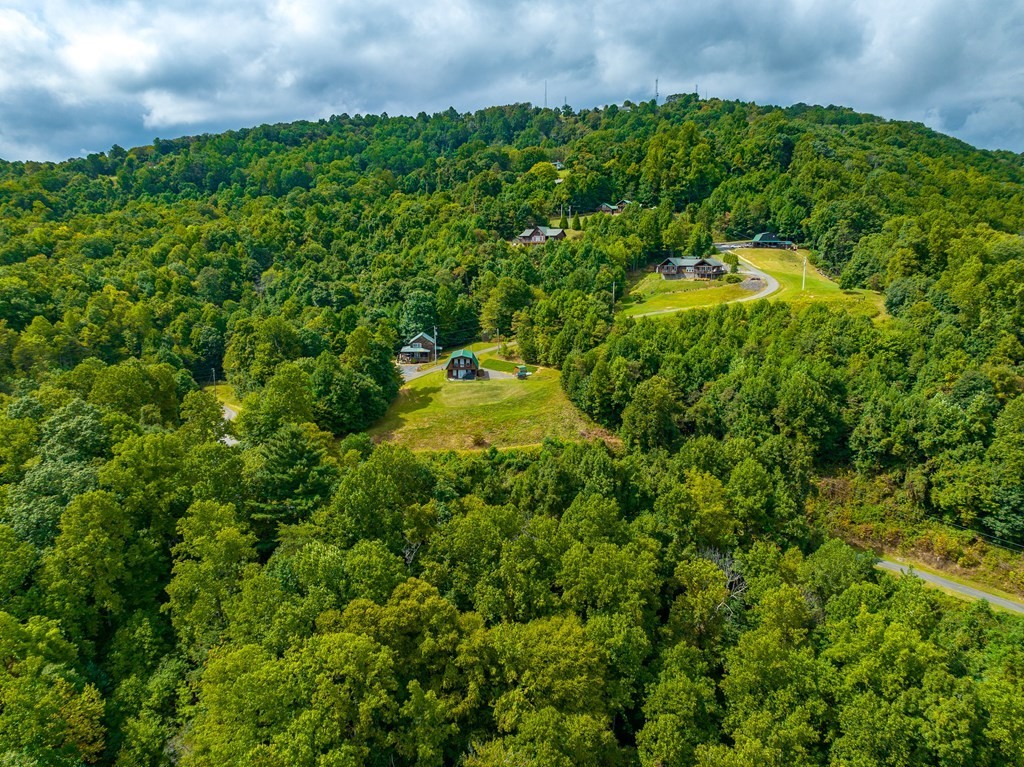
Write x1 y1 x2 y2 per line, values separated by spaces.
0 95 1024 767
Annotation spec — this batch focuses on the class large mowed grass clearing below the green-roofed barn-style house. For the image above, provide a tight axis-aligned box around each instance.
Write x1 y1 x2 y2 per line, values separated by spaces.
370 369 609 451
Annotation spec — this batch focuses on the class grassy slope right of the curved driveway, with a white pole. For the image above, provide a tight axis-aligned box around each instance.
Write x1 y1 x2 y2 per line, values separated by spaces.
732 248 886 318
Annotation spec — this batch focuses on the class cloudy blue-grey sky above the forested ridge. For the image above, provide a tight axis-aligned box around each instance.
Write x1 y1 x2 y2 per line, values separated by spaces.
0 0 1024 160
